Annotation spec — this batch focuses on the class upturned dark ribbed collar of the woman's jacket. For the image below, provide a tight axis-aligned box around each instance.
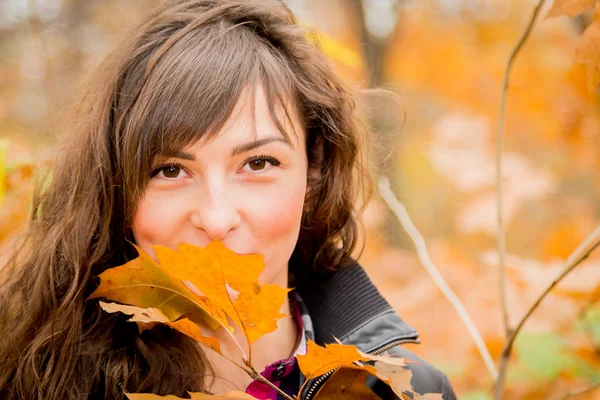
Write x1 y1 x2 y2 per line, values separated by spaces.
302 260 418 352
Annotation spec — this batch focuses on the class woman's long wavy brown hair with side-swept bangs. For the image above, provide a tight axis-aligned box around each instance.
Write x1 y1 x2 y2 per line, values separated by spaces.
0 0 370 400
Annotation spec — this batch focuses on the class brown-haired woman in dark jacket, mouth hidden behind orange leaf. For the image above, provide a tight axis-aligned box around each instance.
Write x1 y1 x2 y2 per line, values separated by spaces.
0 0 454 400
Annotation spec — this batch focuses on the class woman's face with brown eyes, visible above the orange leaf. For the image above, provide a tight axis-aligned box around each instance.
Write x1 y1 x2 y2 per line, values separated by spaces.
133 86 307 287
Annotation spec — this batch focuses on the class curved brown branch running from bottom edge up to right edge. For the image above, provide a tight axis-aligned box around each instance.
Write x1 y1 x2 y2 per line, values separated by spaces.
496 226 600 399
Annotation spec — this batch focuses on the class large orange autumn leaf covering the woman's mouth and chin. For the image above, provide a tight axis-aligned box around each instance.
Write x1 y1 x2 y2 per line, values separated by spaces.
90 241 288 360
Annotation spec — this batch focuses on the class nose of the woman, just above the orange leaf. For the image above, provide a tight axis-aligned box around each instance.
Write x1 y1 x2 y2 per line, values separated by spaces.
190 184 241 240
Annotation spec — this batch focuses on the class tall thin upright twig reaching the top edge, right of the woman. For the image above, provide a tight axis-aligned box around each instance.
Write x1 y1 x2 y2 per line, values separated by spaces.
496 0 545 337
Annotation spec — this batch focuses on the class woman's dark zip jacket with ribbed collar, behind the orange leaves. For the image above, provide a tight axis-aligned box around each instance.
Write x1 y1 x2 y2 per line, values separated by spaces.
300 262 456 400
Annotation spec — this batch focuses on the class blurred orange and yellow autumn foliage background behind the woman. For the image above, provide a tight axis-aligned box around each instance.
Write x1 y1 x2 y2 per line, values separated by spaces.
0 0 600 400
